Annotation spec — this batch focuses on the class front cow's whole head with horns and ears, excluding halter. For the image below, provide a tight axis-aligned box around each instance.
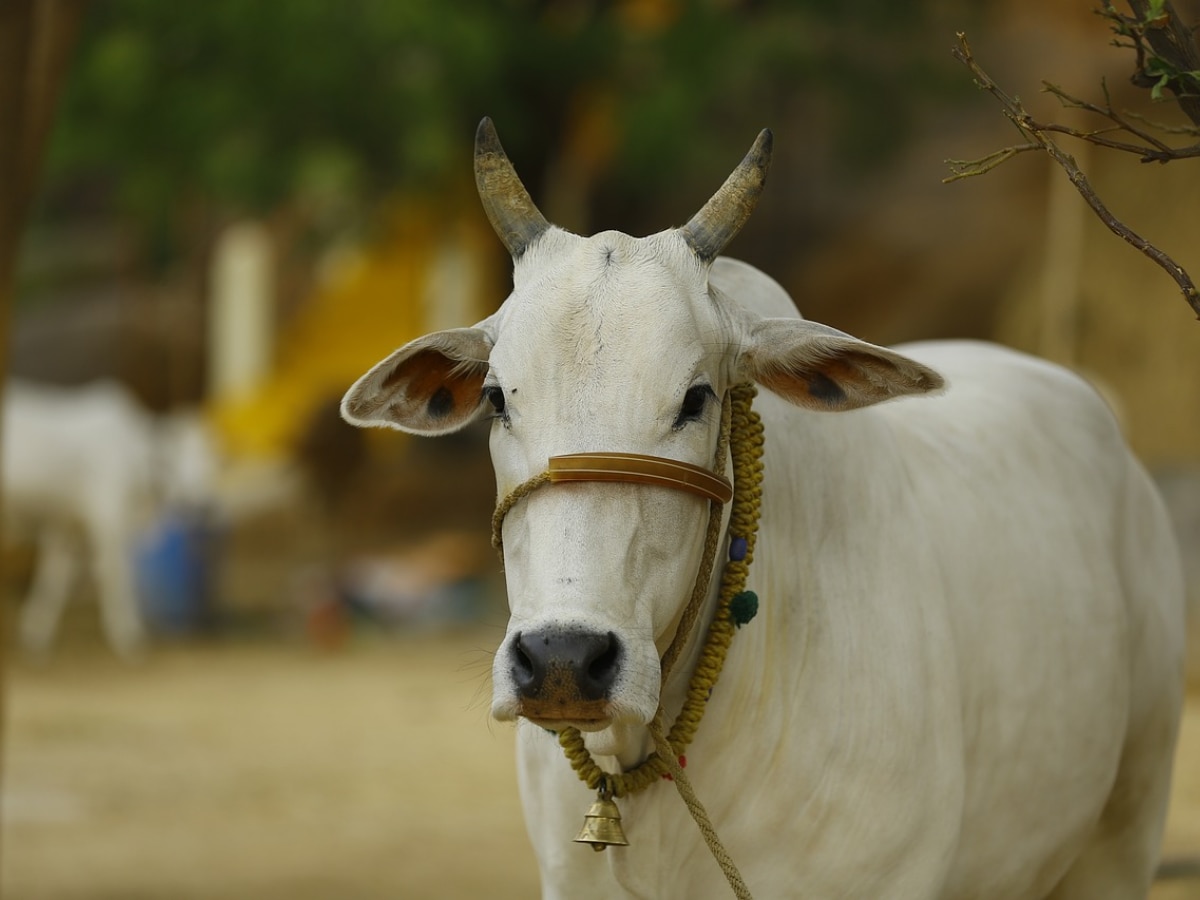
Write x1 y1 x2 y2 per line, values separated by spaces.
342 120 941 753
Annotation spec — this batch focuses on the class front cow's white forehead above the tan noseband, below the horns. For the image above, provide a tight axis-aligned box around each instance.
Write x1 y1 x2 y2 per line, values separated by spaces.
485 232 740 480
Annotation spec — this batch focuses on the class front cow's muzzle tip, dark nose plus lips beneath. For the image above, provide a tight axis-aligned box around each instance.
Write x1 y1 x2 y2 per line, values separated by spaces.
509 629 623 725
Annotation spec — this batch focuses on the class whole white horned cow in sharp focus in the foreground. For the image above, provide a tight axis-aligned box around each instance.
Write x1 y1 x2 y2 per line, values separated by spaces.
343 120 1183 900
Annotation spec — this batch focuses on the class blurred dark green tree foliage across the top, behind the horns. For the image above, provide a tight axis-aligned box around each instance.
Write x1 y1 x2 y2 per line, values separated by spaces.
39 0 974 274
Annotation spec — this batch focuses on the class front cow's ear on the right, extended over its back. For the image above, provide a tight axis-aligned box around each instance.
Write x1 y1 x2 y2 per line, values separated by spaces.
742 319 943 412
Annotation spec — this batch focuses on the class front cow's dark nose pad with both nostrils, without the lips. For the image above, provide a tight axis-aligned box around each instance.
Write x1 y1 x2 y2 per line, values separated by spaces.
512 630 620 701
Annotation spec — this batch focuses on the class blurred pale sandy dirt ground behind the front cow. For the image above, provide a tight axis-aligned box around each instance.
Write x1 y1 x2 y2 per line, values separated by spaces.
0 626 1200 900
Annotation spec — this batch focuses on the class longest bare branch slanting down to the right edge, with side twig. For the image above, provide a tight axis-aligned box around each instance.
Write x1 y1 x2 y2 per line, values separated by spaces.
944 31 1200 319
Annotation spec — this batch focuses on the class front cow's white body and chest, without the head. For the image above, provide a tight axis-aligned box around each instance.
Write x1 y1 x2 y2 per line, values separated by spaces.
518 256 1182 899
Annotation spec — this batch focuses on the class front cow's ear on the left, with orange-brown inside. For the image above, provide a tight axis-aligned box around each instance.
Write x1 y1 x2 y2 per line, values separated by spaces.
342 328 492 436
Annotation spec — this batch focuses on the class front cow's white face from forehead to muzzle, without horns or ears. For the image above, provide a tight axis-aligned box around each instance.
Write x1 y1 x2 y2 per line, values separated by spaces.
482 232 736 727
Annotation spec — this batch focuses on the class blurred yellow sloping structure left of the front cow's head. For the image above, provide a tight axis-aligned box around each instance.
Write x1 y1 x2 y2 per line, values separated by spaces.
211 206 499 457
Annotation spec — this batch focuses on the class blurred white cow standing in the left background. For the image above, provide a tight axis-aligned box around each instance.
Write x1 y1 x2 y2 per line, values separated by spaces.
2 380 216 658
